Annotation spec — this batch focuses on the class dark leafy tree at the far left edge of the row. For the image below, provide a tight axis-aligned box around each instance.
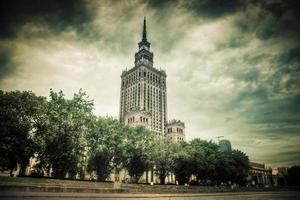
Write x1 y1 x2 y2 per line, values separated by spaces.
0 91 45 175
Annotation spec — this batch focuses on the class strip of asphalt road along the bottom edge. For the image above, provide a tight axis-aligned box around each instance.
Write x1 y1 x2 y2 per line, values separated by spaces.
0 191 300 200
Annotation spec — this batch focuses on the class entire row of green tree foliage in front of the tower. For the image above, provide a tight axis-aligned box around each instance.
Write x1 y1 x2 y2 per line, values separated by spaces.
0 90 251 185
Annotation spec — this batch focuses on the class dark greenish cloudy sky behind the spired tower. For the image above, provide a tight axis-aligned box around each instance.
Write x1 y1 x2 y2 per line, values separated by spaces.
0 0 300 166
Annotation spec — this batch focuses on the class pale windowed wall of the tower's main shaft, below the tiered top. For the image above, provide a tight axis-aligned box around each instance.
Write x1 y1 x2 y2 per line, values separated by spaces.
120 65 167 136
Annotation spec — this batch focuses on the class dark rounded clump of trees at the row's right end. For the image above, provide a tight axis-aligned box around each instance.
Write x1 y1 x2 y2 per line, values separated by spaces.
174 138 249 185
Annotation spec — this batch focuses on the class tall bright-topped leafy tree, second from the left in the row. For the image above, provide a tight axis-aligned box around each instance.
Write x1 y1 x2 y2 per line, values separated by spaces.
37 90 93 178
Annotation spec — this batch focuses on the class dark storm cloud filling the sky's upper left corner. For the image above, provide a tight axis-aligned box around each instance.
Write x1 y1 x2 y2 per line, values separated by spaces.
0 0 91 38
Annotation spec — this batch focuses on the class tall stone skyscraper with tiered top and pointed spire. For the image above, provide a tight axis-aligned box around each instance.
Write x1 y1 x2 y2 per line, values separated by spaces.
119 18 185 142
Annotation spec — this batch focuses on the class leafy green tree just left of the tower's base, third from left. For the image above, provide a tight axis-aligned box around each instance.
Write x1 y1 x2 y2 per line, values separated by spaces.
87 117 126 181
